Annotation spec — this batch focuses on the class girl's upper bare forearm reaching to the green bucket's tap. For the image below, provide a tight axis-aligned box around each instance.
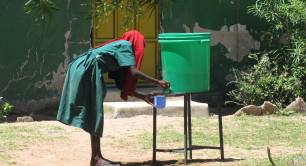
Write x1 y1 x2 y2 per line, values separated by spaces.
130 66 169 88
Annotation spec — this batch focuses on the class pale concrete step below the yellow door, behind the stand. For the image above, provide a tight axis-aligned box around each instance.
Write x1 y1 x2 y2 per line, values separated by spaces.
103 97 209 118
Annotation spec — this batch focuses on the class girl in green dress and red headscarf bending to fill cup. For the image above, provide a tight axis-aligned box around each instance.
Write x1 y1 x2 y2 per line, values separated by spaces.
57 30 169 166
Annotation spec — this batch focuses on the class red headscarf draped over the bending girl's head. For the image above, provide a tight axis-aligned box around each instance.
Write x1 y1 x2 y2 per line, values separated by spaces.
95 30 145 100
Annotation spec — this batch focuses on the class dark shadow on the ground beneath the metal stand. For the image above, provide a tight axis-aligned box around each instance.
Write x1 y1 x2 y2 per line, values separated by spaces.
120 158 243 166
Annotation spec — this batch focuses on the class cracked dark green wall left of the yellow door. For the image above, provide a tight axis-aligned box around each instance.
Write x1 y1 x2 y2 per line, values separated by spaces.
0 0 91 111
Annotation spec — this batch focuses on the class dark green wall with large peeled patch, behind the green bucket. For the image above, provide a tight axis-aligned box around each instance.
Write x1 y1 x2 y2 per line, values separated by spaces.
161 0 265 102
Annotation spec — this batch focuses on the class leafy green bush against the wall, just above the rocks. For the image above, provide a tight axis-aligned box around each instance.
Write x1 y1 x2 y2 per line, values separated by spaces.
228 51 306 109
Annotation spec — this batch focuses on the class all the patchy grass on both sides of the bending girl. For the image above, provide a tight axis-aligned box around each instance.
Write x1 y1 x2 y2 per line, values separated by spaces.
0 114 306 166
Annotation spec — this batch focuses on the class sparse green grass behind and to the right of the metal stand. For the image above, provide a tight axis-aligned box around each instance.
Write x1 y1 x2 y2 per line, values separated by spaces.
138 115 306 165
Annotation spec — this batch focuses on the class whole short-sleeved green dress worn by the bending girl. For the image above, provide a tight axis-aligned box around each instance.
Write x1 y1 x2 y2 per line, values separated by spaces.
57 40 135 137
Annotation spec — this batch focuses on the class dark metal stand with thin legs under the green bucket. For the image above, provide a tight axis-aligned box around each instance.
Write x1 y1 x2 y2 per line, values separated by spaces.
152 93 224 165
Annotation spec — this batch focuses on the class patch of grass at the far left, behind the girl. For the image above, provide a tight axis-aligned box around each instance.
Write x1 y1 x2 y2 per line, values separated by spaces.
0 123 66 162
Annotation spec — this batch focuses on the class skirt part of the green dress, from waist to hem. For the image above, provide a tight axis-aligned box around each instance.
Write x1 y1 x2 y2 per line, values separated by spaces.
57 50 106 137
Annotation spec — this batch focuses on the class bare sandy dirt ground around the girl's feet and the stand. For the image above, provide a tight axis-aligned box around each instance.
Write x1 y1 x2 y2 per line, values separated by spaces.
0 116 304 166
